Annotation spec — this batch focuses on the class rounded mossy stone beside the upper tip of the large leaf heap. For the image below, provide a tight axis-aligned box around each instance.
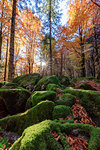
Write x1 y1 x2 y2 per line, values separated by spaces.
56 93 75 107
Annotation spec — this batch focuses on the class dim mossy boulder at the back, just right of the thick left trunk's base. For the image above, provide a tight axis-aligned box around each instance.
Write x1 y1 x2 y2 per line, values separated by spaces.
13 73 41 90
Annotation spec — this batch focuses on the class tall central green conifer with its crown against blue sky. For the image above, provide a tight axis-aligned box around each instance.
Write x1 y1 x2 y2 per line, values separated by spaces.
36 0 60 75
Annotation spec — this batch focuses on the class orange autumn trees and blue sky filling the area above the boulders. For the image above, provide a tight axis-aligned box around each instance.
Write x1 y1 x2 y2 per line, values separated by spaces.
0 0 100 81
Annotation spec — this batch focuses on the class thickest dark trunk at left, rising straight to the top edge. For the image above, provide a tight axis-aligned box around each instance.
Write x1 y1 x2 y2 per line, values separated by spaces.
8 0 17 81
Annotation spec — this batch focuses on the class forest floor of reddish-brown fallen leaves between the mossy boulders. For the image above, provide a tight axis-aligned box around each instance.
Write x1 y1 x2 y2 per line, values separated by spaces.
0 76 100 150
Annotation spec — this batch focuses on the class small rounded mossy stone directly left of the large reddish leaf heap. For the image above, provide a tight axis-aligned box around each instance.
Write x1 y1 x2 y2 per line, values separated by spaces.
53 105 72 119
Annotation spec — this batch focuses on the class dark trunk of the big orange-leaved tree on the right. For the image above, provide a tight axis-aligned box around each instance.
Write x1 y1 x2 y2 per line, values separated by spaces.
79 27 86 77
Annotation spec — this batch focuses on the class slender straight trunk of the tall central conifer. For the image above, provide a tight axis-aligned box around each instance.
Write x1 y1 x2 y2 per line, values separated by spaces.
49 0 52 75
